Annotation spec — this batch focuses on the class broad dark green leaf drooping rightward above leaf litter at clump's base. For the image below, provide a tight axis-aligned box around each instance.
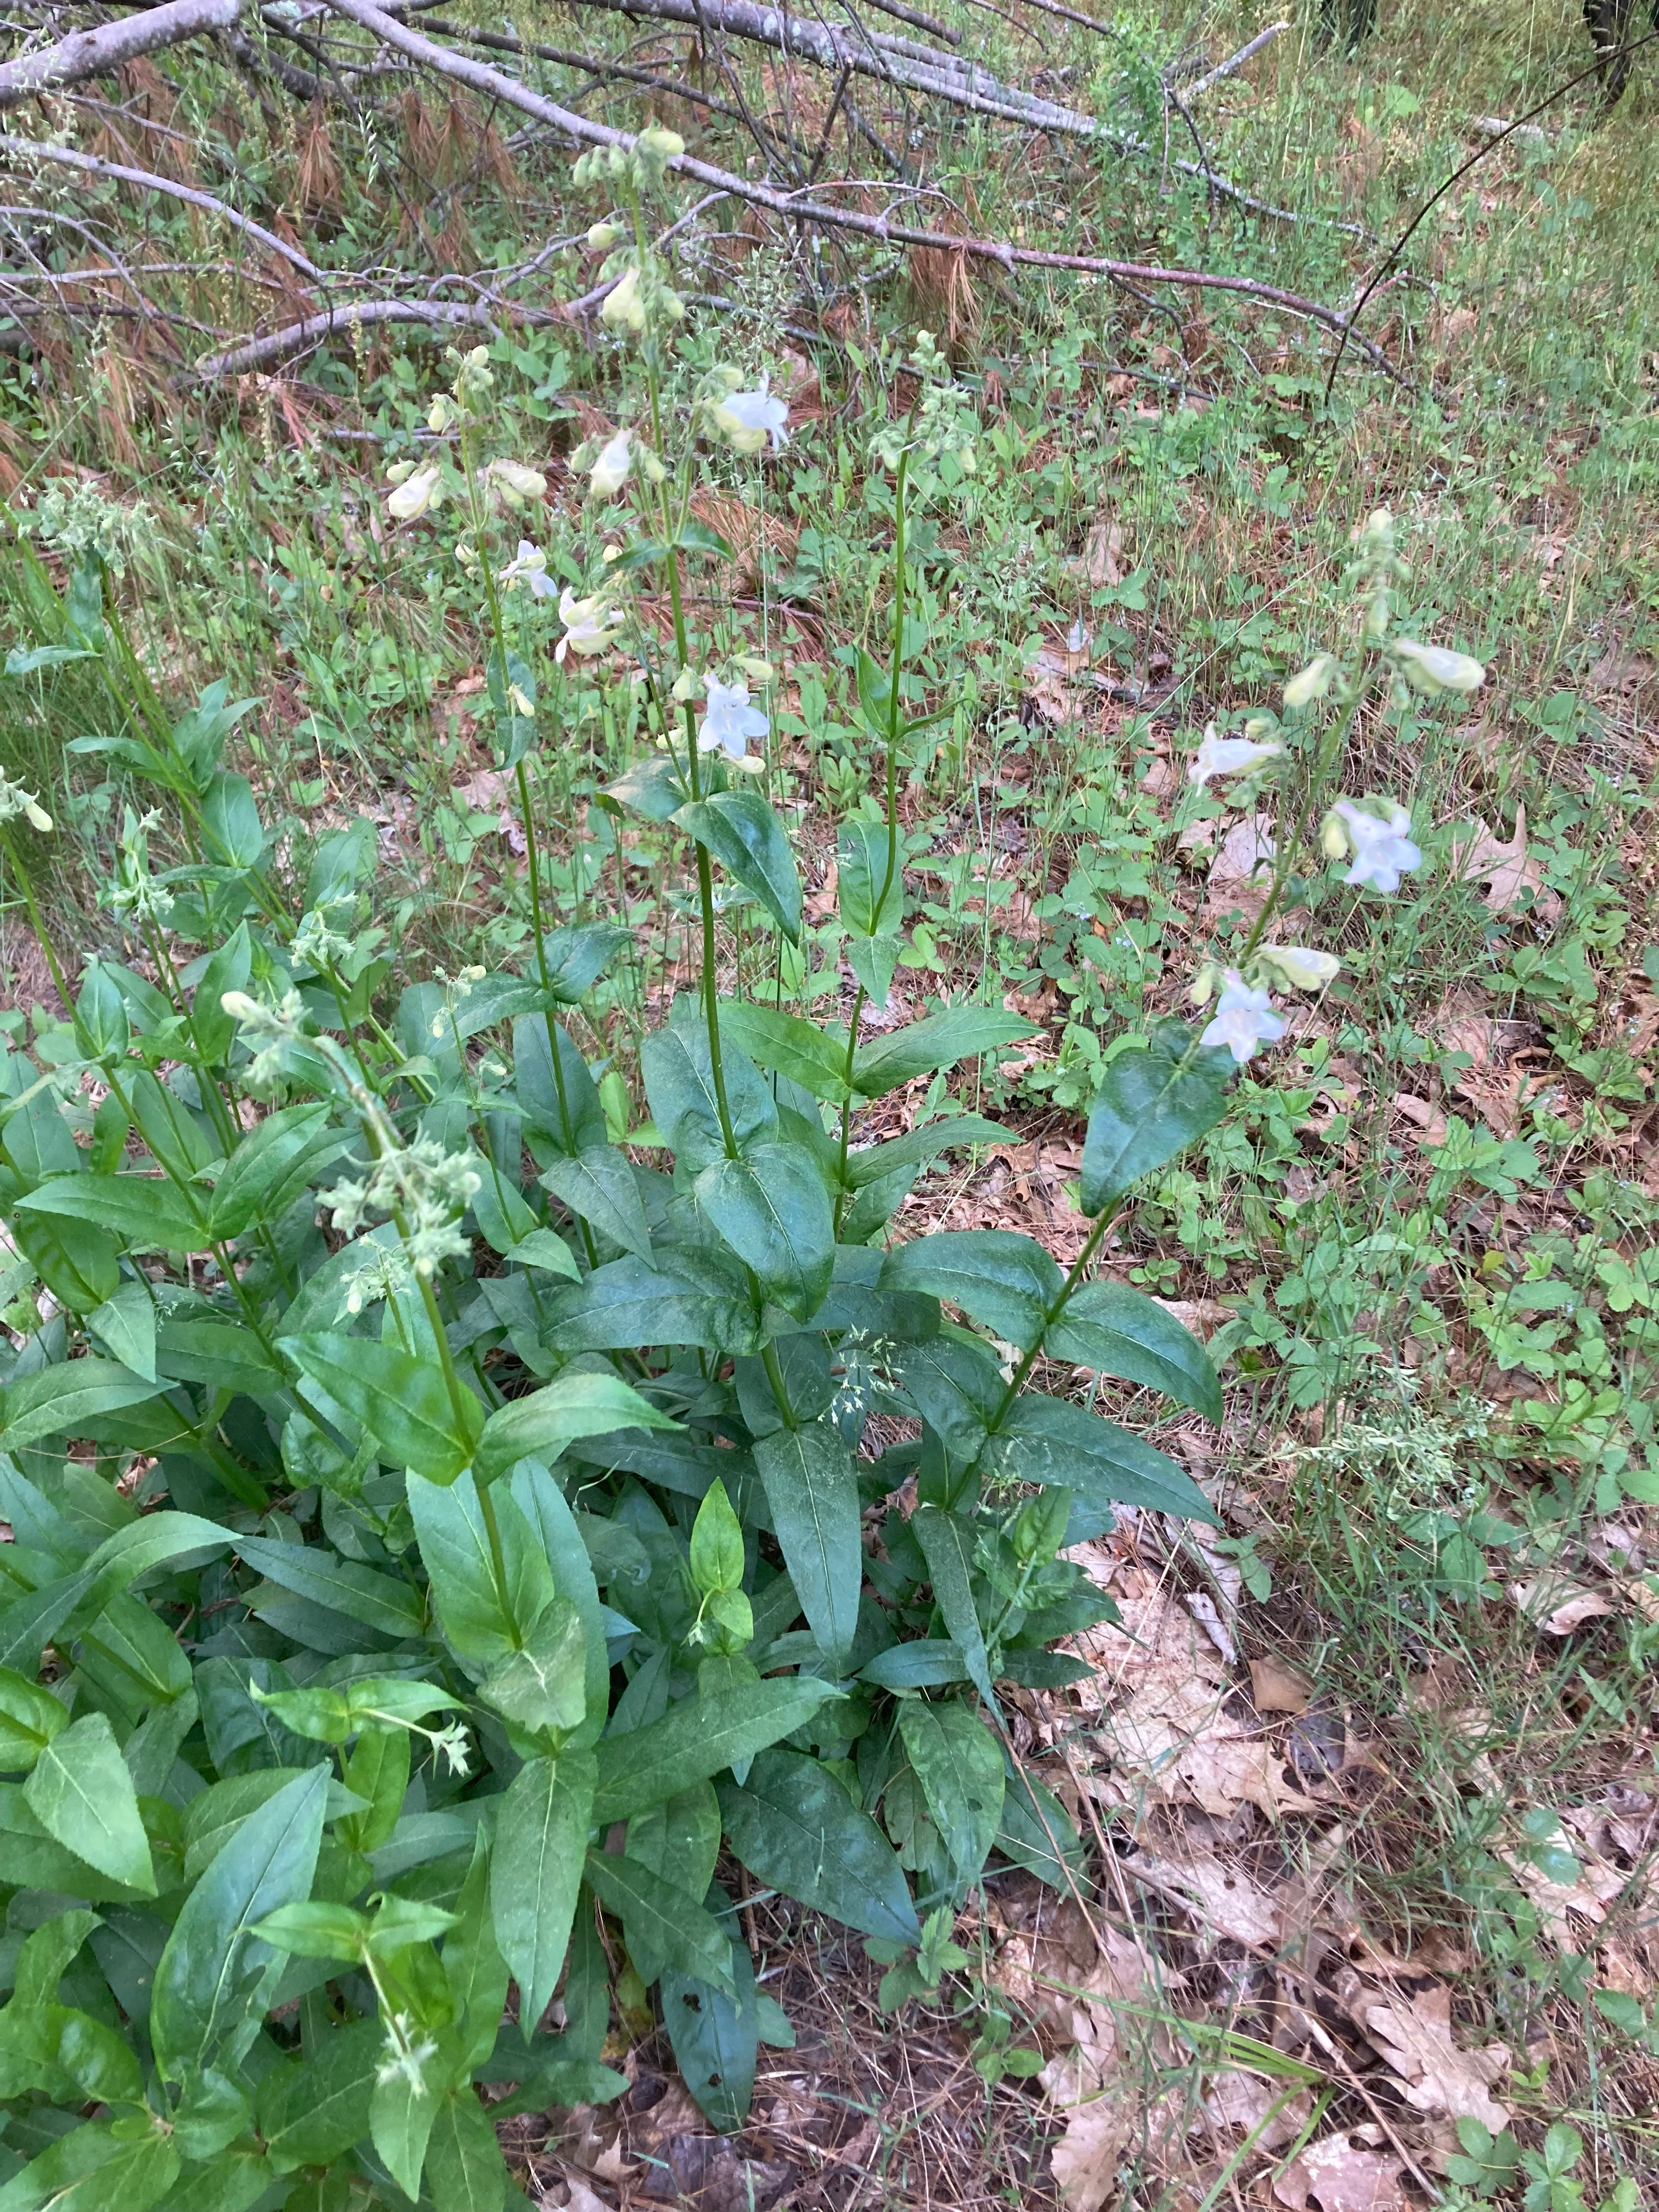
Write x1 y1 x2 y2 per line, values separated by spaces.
716 1750 922 1944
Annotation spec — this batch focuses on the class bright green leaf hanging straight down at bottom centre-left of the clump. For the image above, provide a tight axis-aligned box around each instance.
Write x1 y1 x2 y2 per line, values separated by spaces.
489 1750 595 2026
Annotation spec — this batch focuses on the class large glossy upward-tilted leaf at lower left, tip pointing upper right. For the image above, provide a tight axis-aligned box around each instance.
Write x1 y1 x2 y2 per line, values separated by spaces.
150 1763 330 2081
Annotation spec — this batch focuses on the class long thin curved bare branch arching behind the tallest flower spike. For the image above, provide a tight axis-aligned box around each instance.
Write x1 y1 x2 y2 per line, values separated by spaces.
314 0 1400 378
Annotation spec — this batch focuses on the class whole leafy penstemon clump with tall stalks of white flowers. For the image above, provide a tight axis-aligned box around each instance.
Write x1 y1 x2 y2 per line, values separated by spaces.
0 133 1473 2212
